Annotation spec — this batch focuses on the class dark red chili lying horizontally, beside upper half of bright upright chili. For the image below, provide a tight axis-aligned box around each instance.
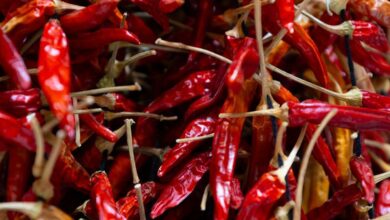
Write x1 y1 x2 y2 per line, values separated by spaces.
69 28 140 50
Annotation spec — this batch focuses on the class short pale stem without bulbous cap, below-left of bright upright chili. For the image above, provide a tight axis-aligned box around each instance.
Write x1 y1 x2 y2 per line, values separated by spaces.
31 115 45 178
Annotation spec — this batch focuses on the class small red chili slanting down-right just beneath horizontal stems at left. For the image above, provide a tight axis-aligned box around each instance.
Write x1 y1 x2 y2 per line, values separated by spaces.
79 114 118 142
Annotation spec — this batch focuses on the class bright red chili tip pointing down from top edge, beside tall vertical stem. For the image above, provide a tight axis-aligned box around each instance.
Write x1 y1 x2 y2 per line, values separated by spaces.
275 0 295 33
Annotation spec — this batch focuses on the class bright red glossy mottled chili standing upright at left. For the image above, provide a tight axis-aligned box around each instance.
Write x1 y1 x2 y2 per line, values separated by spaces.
38 20 75 139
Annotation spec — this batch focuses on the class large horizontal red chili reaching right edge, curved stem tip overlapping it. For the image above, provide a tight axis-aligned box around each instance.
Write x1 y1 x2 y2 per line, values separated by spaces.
287 100 390 130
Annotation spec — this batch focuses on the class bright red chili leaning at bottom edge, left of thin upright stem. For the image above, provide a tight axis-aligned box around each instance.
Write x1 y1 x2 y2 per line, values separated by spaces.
91 171 125 220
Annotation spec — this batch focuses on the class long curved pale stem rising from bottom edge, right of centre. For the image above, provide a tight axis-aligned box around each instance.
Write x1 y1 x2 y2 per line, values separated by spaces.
293 109 337 220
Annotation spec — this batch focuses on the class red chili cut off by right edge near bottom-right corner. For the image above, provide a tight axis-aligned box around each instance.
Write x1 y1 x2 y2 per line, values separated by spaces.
375 180 390 216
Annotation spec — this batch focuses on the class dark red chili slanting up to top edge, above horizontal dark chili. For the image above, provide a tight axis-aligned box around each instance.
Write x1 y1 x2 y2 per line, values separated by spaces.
60 0 119 34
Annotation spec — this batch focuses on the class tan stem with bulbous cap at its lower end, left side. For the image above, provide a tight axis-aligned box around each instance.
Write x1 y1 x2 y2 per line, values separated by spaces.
33 130 65 200
